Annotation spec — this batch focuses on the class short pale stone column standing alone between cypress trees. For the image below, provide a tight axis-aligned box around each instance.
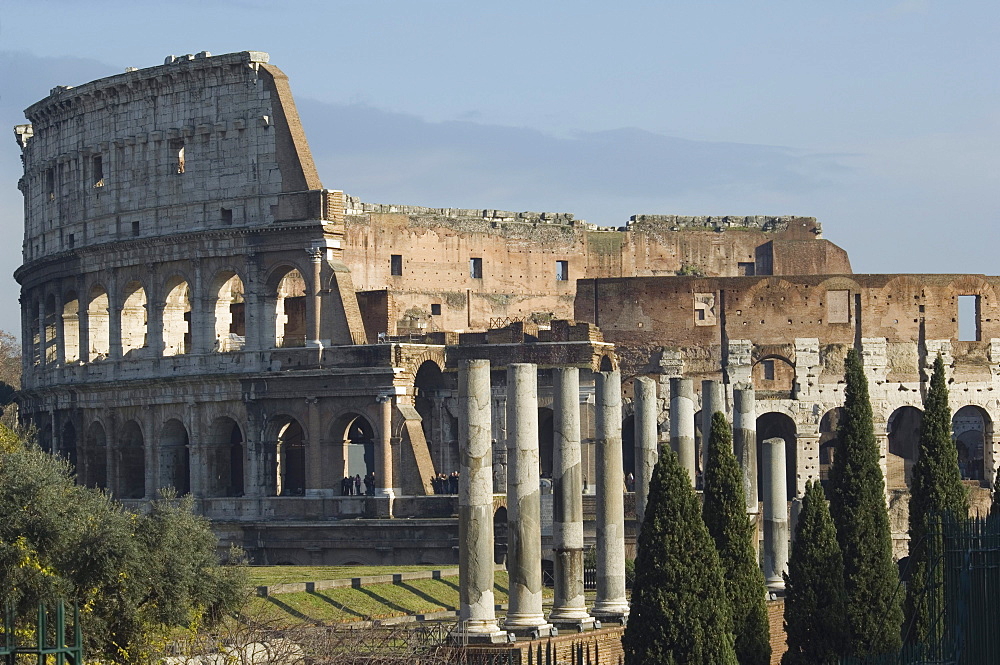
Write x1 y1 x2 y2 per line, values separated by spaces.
761 438 788 591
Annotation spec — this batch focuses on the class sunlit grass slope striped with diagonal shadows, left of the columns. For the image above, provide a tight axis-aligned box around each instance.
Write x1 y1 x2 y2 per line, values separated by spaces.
247 566 512 626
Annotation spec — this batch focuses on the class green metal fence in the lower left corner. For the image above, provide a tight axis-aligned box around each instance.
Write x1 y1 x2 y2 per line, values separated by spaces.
0 601 83 665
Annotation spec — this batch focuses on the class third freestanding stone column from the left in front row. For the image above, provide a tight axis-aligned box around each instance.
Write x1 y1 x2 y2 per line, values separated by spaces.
549 367 594 631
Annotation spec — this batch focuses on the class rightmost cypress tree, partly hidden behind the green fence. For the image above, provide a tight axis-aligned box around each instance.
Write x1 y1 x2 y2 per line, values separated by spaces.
906 354 969 643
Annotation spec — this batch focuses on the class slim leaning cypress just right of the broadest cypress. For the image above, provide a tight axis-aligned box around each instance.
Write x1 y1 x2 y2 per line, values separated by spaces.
702 413 771 665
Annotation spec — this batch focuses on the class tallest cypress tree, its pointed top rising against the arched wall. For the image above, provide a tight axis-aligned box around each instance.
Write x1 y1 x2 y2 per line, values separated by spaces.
830 349 903 657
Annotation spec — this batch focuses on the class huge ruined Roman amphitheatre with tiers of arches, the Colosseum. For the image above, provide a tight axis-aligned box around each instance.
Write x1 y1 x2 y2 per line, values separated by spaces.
9 51 1000 564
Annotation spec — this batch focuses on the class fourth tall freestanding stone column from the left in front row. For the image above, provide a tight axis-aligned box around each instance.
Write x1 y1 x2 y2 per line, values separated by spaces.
591 371 628 623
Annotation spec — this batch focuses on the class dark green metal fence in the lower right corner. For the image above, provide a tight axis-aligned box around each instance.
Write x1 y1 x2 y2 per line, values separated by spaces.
842 515 1000 665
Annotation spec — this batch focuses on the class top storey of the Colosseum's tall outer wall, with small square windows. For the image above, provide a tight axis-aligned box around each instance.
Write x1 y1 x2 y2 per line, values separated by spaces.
15 51 323 263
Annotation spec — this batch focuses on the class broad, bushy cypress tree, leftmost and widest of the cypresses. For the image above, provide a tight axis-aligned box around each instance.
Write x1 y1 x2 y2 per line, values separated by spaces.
622 448 737 665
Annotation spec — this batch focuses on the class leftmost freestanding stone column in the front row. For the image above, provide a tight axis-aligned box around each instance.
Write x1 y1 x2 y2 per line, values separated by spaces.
456 360 507 643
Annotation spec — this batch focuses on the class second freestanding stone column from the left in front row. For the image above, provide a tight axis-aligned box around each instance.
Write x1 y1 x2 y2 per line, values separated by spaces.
503 363 552 639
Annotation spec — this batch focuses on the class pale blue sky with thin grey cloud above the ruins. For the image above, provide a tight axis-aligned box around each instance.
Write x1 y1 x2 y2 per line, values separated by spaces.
0 0 1000 331
